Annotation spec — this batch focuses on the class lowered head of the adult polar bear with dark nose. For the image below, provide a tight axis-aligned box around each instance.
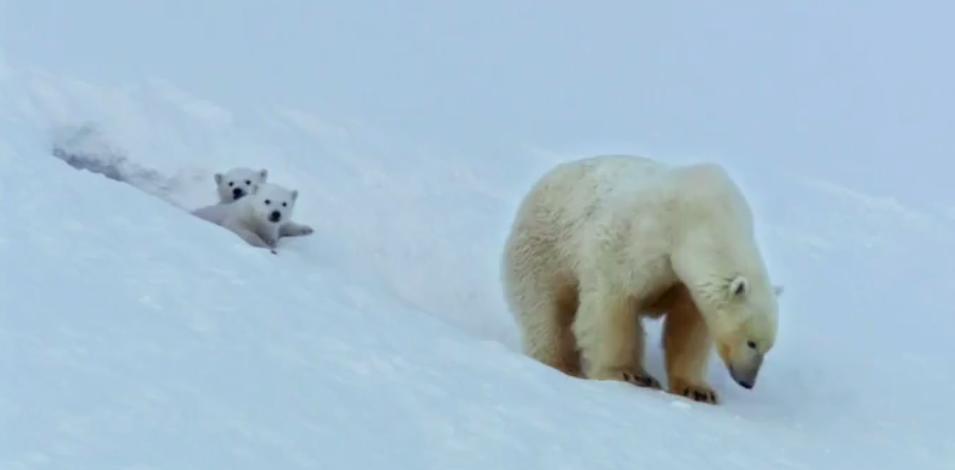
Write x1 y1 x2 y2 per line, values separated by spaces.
705 275 782 388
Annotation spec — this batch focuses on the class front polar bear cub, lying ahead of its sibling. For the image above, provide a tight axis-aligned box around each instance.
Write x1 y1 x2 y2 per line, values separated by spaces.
192 183 298 253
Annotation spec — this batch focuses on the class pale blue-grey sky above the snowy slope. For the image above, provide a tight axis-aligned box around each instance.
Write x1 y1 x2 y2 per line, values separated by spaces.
0 0 955 206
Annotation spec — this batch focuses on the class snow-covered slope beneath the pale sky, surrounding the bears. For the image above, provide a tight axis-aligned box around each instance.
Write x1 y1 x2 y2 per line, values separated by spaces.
0 3 955 469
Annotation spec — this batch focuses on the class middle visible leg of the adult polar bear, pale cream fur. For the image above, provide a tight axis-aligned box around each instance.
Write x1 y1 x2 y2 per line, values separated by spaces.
573 290 660 388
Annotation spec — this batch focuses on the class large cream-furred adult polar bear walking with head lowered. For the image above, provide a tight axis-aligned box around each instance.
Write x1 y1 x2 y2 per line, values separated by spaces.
503 156 777 403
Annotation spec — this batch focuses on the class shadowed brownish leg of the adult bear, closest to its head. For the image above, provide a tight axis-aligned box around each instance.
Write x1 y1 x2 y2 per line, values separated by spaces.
663 290 719 404
